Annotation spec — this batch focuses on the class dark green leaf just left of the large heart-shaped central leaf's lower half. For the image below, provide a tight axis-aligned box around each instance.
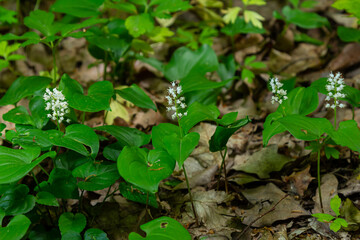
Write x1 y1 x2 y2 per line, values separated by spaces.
72 161 120 191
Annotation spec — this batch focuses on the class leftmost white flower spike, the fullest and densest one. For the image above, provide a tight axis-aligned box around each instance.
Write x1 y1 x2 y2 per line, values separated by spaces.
43 88 70 123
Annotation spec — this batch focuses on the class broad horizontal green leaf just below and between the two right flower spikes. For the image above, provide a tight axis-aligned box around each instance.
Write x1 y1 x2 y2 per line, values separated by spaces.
277 115 332 141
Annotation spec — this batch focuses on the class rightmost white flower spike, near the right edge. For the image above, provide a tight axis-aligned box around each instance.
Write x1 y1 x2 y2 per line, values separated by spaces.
325 72 345 109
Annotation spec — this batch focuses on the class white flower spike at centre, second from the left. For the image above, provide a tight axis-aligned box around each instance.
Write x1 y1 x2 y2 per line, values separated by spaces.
166 81 187 119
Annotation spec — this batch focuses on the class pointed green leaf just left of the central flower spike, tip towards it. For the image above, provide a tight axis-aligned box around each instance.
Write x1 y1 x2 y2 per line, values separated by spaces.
115 84 157 111
